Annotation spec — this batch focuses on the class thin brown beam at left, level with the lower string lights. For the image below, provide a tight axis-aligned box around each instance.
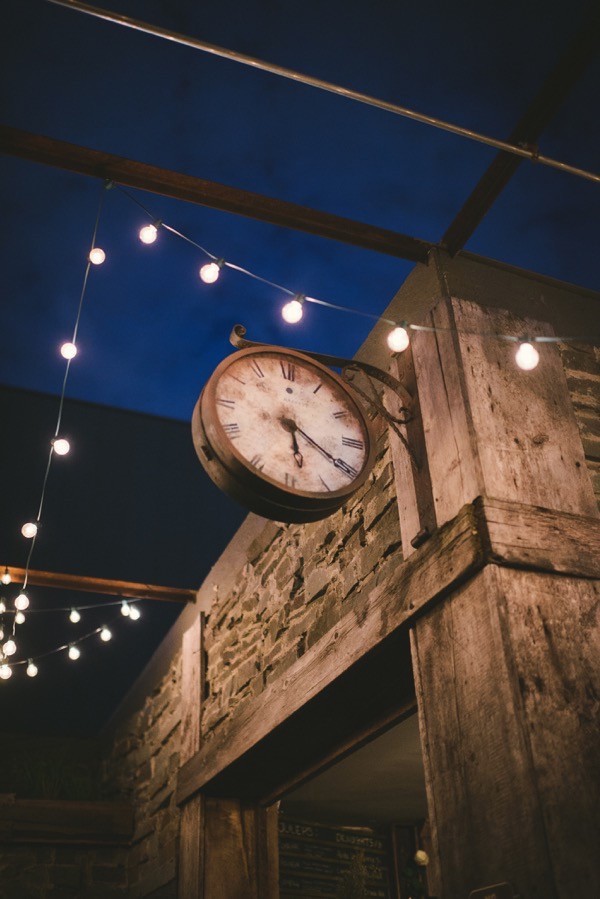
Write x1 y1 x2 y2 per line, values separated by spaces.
0 565 196 603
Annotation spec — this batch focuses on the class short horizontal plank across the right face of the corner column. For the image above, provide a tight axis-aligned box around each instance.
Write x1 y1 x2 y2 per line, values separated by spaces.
475 498 600 578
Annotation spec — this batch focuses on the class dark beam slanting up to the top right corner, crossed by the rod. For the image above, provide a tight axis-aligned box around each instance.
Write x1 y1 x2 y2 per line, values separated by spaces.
442 15 600 256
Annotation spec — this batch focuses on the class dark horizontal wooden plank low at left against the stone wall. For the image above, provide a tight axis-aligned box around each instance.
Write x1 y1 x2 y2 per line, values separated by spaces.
0 798 133 846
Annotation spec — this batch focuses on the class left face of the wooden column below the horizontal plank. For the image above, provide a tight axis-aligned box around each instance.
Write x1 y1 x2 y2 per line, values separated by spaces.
412 566 556 899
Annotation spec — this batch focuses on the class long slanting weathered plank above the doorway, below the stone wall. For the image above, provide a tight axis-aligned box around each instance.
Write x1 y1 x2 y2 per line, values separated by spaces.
177 506 485 803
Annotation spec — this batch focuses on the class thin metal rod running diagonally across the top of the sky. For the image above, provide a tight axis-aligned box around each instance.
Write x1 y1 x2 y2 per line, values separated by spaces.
48 0 600 183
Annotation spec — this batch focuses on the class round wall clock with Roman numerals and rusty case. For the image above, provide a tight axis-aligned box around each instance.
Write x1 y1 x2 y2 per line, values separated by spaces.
192 346 375 522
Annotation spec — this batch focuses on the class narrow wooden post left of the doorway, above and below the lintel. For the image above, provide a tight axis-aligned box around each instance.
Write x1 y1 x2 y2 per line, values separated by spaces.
178 615 279 899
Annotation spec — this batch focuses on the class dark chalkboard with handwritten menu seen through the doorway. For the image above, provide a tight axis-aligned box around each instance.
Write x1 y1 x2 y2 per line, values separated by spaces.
279 816 391 899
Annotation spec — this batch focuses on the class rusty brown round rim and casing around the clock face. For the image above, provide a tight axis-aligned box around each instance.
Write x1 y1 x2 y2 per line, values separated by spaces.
192 345 375 522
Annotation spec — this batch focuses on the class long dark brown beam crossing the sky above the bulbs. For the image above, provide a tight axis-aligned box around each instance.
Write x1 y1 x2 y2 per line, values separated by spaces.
0 125 433 263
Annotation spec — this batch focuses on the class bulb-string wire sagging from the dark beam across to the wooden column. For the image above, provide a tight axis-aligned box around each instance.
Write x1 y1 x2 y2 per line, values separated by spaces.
113 183 593 343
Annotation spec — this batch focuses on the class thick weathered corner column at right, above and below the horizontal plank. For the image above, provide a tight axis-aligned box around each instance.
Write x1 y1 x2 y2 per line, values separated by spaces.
390 298 600 899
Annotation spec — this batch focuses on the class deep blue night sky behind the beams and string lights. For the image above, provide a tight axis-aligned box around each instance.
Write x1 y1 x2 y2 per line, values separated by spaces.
0 0 600 732
